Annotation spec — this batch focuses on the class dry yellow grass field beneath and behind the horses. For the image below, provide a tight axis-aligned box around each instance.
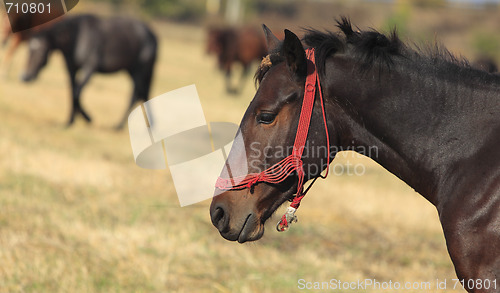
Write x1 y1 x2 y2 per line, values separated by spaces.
0 10 472 292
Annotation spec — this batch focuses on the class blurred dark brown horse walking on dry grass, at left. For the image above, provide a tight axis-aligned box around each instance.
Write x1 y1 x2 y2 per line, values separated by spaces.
21 14 158 129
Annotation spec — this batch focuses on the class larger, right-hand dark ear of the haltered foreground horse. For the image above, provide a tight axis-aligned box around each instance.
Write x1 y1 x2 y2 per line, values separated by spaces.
281 30 307 76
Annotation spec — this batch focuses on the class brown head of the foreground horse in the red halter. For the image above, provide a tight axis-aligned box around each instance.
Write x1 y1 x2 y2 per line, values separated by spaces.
210 26 328 243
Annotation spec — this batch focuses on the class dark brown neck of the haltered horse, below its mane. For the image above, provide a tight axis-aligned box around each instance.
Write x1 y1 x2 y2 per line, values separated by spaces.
323 57 500 205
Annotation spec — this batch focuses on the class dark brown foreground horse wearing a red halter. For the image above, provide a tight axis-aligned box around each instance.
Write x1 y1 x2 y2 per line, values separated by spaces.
210 17 500 292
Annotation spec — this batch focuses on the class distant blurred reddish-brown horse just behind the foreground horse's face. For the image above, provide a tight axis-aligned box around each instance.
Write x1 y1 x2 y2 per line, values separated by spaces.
207 27 267 94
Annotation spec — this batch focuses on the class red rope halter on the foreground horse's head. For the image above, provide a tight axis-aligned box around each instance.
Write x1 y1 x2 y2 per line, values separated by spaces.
215 48 330 232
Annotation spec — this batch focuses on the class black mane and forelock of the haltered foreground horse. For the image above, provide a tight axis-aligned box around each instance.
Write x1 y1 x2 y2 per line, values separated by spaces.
255 17 488 83
